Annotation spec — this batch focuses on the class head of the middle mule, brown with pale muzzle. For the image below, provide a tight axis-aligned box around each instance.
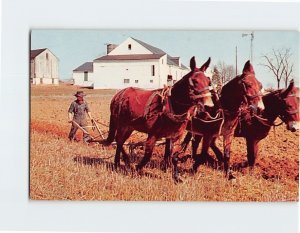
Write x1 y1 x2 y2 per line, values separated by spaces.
240 61 265 111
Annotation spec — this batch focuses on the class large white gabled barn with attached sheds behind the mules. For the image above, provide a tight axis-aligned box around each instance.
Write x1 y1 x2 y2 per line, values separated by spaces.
73 37 189 89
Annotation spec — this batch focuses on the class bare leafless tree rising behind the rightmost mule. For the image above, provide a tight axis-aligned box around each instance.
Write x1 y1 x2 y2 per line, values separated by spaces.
260 48 294 89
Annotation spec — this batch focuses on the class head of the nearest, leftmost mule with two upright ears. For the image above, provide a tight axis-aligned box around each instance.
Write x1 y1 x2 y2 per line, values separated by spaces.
188 57 214 107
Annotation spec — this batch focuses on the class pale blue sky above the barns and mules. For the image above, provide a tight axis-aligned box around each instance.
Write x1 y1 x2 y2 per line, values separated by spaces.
31 29 300 88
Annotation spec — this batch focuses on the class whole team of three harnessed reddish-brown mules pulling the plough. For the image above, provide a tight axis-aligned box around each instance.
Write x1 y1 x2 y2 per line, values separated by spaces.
104 57 299 182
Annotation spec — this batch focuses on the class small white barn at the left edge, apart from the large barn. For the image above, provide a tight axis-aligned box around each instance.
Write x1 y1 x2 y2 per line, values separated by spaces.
30 48 59 85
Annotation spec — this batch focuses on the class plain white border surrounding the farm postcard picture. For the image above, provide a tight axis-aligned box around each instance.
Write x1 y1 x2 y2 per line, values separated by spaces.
0 0 300 233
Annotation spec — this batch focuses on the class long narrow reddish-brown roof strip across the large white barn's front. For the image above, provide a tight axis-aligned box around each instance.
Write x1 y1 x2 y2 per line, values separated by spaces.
94 54 164 61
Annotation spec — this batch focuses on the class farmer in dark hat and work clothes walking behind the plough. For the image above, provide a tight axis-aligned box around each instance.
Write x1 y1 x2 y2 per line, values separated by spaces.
68 91 93 143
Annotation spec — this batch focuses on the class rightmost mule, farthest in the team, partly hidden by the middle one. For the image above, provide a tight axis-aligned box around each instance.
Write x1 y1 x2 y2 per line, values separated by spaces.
188 80 299 174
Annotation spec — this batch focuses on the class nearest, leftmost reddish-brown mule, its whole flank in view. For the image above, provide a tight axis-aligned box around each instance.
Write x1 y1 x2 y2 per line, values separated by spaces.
104 57 213 171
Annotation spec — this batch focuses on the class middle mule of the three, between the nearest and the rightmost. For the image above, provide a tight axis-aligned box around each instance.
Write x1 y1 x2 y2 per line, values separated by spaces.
176 61 264 179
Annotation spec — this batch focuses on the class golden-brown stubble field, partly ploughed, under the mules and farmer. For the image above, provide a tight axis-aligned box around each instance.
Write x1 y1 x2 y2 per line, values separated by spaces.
30 84 299 201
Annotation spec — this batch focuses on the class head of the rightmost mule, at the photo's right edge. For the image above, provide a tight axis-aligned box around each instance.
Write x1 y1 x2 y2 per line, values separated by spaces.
279 80 299 132
